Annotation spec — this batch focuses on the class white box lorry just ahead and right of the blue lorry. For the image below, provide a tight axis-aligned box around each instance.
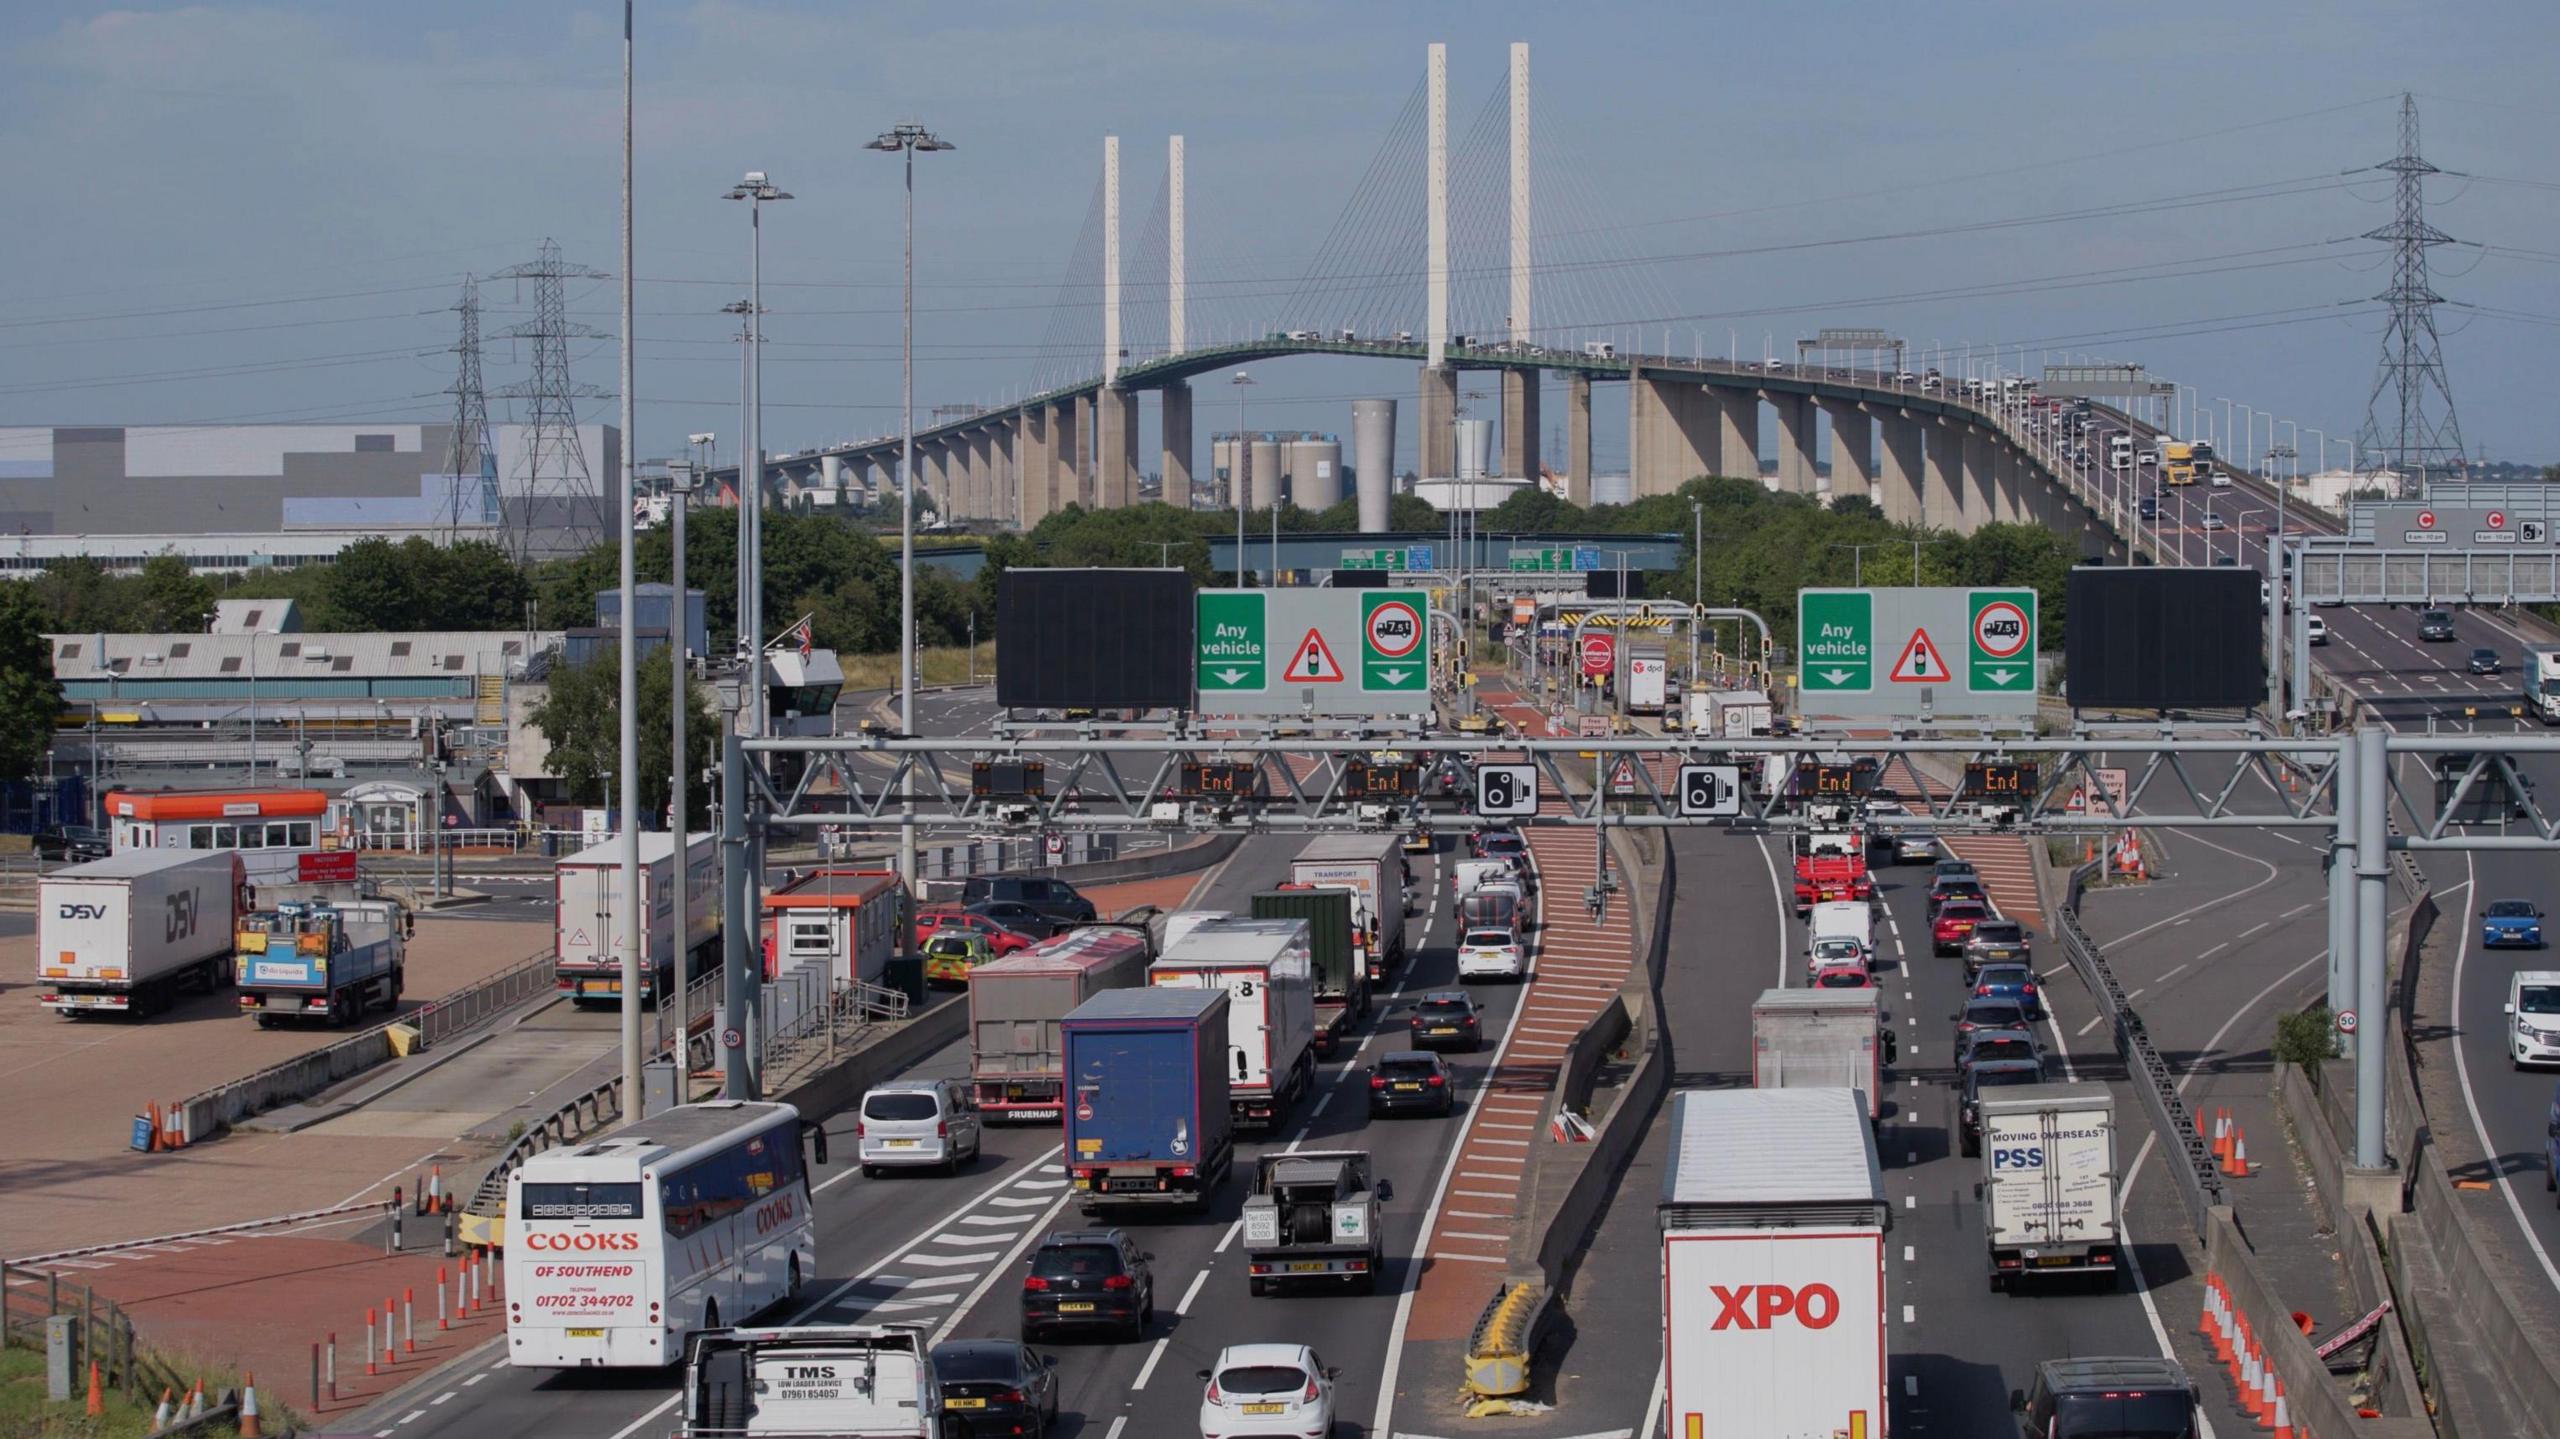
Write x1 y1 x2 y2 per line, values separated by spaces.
1147 919 1316 1129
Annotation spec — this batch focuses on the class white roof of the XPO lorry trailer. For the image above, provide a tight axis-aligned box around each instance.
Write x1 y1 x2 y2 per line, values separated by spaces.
1661 1088 1884 1206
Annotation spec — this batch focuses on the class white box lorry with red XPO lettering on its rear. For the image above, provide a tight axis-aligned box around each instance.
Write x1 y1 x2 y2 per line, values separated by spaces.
1656 1088 1892 1439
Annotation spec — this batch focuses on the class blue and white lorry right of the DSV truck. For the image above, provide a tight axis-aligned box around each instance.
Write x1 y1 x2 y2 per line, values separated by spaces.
238 899 410 1029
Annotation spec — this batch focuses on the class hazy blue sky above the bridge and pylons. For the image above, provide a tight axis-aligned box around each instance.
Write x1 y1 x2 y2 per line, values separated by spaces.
0 0 2560 469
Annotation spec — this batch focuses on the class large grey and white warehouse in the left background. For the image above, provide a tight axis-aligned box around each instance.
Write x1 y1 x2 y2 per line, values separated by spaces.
0 425 622 574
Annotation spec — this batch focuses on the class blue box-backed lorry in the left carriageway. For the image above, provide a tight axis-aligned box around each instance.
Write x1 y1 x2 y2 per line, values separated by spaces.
1062 986 1236 1216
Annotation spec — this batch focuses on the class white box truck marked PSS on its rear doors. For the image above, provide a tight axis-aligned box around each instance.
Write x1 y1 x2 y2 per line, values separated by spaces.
1981 1083 2122 1290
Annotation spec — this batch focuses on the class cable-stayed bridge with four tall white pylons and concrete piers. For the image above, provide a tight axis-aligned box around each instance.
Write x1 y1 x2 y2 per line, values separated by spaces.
714 44 2163 545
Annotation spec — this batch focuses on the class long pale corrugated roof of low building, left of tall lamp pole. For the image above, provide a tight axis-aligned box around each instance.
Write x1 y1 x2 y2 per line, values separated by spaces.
46 630 561 681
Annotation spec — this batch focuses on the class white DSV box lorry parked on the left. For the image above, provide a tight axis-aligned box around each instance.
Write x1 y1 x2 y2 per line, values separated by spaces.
36 850 248 1019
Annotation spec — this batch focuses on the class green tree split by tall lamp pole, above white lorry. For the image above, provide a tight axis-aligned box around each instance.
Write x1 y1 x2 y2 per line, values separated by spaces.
527 645 719 817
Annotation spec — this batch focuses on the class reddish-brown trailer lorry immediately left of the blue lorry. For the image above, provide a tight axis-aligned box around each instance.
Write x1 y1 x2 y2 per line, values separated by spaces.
968 924 1155 1124
